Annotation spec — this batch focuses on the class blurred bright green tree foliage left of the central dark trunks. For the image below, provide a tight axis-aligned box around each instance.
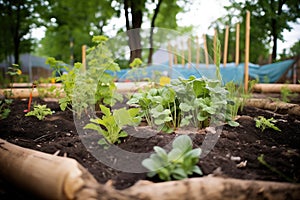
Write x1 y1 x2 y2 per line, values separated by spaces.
38 0 117 64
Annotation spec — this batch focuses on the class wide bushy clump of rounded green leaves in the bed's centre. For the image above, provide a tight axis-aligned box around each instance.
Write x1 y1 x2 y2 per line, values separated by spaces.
127 76 238 133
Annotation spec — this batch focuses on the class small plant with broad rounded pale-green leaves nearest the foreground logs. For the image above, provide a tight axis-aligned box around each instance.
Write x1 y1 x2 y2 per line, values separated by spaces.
142 135 202 181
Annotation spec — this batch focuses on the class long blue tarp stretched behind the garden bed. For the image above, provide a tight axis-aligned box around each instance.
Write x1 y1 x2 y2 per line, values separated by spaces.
109 60 294 84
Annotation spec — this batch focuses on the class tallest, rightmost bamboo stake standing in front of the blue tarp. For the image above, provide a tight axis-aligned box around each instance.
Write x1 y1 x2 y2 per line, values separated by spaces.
244 11 250 92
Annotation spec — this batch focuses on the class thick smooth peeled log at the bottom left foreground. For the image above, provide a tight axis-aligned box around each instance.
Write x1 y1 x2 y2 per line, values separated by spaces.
0 139 97 199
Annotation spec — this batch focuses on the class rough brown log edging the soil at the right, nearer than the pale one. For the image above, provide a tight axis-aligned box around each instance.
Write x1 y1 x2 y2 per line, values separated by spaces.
246 99 300 116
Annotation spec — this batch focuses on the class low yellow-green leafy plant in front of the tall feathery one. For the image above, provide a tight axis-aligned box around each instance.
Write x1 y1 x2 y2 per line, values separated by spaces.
84 105 141 145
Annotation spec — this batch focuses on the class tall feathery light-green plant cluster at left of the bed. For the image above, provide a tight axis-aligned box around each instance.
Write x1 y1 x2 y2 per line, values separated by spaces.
48 36 122 116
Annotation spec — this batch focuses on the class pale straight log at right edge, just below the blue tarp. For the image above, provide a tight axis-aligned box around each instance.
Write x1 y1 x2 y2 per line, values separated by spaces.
253 83 300 93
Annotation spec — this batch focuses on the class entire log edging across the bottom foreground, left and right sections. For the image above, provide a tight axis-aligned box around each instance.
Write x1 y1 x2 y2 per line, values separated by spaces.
0 139 300 200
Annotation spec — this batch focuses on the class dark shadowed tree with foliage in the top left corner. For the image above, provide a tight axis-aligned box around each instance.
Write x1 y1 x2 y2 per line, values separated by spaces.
0 0 46 64
